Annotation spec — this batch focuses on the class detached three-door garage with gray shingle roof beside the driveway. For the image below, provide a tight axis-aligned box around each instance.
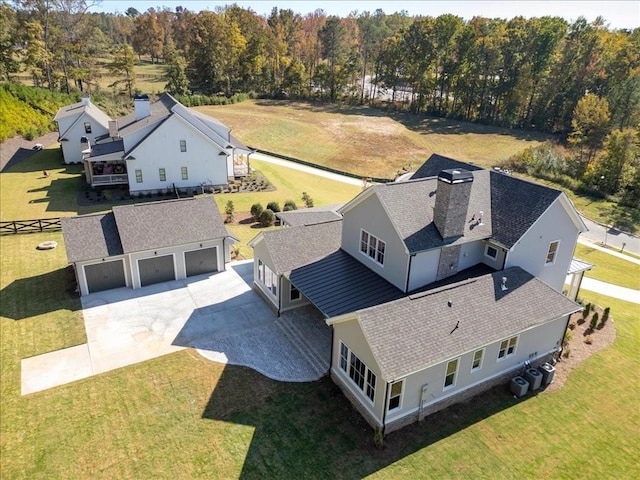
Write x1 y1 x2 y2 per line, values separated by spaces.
62 197 236 295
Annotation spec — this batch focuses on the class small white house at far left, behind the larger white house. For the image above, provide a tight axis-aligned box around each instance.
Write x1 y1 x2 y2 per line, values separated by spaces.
53 97 111 163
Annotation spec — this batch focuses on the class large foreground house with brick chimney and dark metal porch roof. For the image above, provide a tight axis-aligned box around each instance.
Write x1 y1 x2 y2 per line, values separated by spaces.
250 155 586 432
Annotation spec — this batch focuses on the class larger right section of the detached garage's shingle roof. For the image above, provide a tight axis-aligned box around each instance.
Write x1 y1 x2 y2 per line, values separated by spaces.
113 197 232 253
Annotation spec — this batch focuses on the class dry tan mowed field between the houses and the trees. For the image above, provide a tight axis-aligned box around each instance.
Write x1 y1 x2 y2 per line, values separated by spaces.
196 100 551 178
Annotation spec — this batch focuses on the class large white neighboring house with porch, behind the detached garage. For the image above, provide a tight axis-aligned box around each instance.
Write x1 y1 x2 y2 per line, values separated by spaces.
56 93 252 195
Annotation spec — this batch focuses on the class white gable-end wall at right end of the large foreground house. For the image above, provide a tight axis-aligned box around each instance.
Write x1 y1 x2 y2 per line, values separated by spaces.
505 200 579 292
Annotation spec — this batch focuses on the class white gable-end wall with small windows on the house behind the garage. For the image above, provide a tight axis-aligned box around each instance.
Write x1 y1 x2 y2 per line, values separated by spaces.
127 116 228 192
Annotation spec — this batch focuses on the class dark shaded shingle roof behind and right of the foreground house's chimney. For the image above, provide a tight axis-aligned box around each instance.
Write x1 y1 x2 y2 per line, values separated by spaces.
411 154 561 248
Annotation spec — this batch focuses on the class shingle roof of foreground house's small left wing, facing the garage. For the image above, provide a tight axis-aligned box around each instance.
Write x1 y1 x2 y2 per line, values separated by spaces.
262 220 342 274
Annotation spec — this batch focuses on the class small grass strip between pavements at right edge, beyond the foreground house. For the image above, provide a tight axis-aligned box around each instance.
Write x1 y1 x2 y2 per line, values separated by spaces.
575 244 640 290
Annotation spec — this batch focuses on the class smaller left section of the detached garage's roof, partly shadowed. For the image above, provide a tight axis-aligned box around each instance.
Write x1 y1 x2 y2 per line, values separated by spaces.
61 212 123 263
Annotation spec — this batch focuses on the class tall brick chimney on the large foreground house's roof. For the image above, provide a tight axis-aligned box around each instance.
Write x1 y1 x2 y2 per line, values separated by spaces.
433 168 473 240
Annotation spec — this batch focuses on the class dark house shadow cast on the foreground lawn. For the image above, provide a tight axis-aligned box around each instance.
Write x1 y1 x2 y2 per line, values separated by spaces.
202 365 521 479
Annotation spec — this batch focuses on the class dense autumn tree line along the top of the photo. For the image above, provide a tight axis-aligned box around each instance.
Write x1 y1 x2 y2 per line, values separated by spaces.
0 0 640 208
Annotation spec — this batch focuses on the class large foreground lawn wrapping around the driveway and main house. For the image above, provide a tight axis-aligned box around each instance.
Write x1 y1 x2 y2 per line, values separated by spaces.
0 233 640 480
